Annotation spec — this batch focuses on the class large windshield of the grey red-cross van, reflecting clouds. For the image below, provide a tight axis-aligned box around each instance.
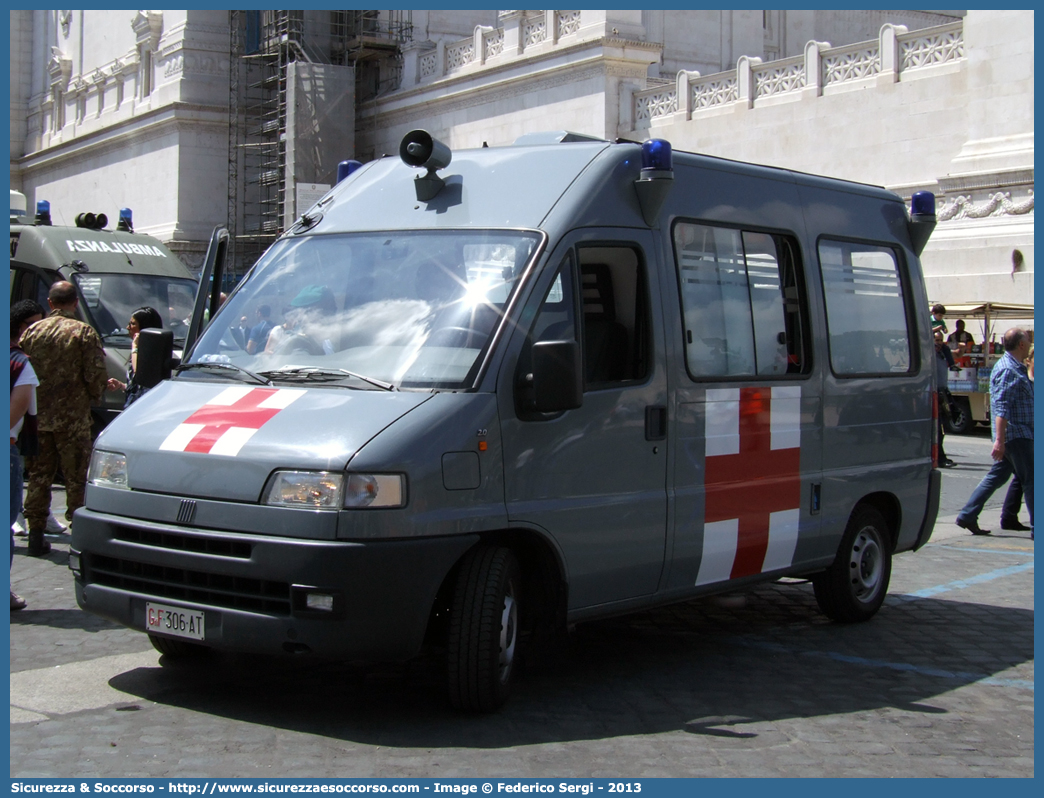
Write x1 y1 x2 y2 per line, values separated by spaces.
188 231 540 390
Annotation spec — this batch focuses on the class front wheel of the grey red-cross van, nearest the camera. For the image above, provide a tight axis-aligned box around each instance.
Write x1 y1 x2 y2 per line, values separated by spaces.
446 546 521 712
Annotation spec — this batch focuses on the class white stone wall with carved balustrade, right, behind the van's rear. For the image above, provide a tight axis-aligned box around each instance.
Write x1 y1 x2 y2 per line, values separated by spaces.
619 11 1034 311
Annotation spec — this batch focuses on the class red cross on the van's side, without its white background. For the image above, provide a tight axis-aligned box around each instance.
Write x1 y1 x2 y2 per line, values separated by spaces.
704 388 801 579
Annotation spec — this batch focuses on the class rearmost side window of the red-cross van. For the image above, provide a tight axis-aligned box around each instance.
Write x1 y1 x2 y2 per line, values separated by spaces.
818 239 911 376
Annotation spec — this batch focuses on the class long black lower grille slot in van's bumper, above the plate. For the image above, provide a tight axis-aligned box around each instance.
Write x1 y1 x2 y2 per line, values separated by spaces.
84 554 290 615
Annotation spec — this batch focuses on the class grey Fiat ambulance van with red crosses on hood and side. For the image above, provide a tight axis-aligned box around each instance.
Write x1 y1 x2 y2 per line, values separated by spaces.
70 131 940 710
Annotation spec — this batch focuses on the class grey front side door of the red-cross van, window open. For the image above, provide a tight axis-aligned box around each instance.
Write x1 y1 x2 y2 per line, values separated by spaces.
498 231 667 610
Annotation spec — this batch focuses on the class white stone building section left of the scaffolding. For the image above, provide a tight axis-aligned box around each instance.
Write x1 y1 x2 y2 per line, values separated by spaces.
9 10 229 265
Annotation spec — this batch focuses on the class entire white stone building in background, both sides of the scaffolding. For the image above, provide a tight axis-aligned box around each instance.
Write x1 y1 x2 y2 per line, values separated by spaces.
10 9 1034 315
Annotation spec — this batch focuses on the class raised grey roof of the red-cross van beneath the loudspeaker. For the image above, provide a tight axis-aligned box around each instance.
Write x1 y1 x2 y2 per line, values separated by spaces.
300 132 901 235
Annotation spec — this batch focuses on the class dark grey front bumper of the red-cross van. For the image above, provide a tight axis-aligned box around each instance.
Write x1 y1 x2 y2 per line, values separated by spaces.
71 508 478 660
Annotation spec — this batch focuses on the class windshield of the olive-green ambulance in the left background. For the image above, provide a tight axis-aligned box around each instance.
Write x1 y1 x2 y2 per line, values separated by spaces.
72 273 196 348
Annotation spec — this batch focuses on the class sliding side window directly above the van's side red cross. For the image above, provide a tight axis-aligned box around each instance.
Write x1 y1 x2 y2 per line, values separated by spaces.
674 221 811 379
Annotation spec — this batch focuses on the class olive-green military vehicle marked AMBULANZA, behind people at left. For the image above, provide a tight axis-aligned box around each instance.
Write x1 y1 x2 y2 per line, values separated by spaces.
10 201 197 429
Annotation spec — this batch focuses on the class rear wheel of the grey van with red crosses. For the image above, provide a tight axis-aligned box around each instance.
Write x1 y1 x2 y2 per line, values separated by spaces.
812 507 892 624
